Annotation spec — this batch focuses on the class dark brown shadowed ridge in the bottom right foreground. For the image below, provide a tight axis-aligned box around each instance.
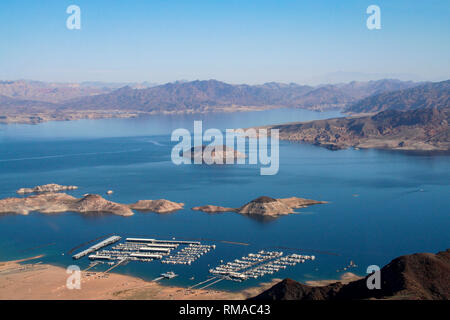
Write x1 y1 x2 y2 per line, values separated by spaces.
250 249 450 300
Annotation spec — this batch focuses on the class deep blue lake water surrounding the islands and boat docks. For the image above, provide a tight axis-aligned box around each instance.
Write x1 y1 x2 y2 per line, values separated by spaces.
0 110 450 290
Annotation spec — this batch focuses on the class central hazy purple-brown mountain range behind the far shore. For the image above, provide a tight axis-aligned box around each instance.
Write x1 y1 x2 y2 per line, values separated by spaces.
58 80 418 112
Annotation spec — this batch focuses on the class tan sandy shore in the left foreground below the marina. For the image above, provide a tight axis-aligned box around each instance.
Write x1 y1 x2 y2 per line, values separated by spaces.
0 256 280 300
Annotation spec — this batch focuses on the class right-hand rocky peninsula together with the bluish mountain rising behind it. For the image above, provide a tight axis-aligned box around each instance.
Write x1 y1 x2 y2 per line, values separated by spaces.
260 80 450 151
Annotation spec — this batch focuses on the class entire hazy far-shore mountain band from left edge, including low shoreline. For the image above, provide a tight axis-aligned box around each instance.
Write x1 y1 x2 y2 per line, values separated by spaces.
0 79 432 123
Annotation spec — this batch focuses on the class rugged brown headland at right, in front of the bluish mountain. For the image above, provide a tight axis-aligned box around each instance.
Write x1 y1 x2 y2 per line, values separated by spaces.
268 108 450 151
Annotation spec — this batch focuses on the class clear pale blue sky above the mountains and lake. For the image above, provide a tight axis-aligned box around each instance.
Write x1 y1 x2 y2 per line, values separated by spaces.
0 0 450 83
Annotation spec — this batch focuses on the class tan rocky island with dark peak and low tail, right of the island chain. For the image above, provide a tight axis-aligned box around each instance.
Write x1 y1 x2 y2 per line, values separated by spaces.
192 196 327 217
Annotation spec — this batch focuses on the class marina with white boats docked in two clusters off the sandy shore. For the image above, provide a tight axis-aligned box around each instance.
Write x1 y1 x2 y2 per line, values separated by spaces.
73 236 316 289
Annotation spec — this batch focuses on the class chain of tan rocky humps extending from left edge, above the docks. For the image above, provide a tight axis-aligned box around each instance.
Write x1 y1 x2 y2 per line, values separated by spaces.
0 192 183 216
